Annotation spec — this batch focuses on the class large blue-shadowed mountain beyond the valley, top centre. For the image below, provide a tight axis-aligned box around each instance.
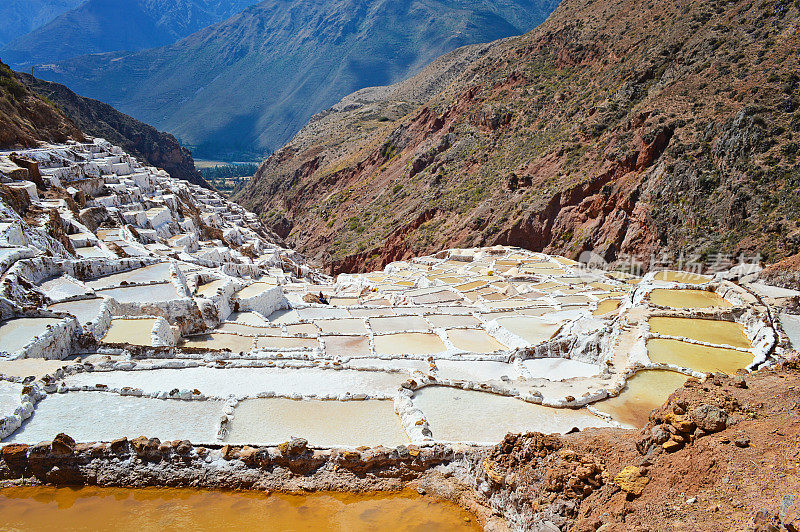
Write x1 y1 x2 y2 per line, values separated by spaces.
29 0 557 160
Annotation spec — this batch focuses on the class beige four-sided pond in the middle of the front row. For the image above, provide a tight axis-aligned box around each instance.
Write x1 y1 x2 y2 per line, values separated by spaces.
225 398 409 447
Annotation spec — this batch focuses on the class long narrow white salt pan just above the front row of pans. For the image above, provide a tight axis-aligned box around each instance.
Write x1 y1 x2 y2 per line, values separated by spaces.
64 367 408 397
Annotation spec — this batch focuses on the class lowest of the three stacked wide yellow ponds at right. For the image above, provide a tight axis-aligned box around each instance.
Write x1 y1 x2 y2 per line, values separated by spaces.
647 338 753 375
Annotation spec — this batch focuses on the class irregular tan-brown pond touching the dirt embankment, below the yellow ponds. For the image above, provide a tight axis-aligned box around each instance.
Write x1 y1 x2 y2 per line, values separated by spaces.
592 370 688 427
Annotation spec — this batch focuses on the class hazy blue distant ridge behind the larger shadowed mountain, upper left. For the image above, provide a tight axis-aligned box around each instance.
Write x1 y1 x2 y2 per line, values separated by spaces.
0 0 256 70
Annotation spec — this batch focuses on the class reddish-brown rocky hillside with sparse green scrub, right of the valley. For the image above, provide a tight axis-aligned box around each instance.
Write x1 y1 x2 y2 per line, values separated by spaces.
239 0 800 271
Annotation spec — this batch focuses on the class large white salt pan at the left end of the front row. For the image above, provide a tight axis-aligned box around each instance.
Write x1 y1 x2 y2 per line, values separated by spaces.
3 392 224 444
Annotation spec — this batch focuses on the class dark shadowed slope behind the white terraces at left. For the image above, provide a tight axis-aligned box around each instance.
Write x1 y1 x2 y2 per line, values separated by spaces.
17 74 211 188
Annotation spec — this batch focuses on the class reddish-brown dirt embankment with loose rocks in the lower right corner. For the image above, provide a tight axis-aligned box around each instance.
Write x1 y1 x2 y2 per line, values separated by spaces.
483 355 800 532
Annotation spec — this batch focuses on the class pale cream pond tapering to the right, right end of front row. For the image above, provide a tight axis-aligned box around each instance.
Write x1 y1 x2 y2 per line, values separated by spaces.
413 386 609 443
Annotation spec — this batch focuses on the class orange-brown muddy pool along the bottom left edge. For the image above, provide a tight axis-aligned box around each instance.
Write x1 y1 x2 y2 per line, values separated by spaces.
0 486 481 532
